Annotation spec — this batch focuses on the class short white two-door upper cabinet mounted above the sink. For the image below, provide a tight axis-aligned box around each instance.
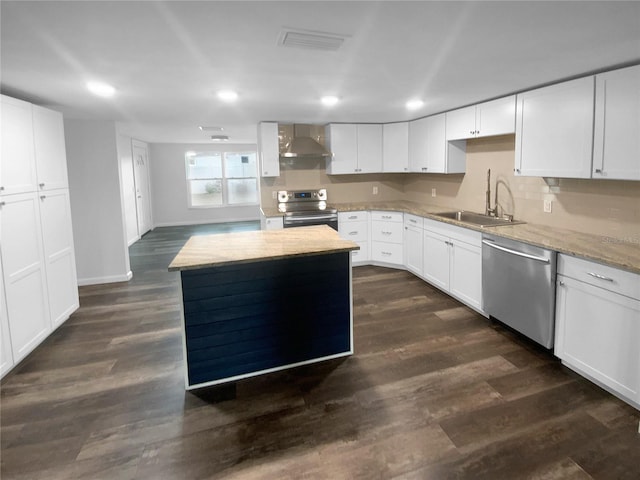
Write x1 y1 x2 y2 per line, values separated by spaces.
446 95 516 140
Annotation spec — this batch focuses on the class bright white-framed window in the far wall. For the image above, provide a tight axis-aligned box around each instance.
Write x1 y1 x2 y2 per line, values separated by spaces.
185 152 258 208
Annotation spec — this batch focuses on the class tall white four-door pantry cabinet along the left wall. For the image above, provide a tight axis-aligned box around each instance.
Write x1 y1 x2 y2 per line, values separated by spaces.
0 95 79 376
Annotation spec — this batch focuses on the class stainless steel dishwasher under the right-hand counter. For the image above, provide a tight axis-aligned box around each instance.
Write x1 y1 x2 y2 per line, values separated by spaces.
482 234 556 348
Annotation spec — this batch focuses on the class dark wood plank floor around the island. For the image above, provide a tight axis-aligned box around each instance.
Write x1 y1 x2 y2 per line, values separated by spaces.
0 223 640 480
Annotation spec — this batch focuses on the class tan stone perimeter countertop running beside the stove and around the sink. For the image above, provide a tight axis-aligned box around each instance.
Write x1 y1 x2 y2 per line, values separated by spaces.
262 201 640 274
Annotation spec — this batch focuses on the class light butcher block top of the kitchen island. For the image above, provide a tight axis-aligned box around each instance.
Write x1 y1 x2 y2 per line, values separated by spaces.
169 225 360 271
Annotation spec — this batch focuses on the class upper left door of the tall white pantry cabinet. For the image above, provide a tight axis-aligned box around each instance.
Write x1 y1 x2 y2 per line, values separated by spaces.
0 95 36 195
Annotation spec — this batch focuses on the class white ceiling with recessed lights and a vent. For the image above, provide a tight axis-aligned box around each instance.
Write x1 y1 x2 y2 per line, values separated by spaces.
0 0 640 143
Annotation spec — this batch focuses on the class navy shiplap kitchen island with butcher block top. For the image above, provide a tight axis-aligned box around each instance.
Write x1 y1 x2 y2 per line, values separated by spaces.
169 225 359 390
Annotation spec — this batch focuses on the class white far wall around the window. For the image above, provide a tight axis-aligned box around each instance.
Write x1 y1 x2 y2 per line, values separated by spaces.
149 143 260 227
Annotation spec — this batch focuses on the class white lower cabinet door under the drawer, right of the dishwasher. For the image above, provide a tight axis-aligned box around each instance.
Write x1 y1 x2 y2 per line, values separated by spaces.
555 276 640 403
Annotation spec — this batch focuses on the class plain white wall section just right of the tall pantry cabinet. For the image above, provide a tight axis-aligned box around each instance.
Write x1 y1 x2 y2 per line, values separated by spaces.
64 119 132 285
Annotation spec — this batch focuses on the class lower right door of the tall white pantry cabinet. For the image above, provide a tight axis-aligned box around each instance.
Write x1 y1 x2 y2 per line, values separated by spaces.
40 189 79 328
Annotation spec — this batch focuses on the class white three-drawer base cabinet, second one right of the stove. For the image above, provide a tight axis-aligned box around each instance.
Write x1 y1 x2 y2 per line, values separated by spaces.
371 211 404 267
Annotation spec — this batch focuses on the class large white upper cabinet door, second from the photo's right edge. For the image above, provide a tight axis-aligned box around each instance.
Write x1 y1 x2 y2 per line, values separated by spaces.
515 77 594 178
